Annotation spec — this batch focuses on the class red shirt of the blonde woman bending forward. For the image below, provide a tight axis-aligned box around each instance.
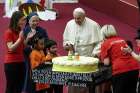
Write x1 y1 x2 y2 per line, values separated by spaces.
100 37 139 75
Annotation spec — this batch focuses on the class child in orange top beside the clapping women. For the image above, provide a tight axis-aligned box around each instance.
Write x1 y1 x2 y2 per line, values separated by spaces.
30 34 49 93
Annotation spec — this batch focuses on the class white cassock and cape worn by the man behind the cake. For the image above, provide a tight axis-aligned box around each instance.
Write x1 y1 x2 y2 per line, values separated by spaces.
63 17 103 56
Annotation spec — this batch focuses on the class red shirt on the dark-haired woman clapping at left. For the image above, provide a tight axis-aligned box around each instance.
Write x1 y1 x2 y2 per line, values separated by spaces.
4 29 24 63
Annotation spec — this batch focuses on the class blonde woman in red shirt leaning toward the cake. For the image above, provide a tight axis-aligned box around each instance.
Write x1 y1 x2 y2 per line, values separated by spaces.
100 25 139 93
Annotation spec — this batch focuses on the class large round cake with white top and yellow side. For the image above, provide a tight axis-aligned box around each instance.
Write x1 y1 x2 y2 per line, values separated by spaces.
52 56 99 73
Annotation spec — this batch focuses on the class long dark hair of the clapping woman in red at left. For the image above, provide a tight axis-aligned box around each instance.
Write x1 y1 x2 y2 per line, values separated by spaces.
9 11 24 31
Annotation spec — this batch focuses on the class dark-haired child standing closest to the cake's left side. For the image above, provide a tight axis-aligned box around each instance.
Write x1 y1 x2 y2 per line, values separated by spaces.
46 40 63 93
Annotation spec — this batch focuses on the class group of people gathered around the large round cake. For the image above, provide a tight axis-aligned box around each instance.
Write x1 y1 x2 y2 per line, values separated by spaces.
4 8 140 93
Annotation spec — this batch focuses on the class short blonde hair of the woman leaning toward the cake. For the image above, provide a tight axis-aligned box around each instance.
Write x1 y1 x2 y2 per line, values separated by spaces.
101 25 117 38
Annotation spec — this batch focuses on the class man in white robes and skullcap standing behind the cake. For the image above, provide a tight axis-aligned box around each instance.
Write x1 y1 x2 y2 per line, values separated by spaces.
63 8 103 93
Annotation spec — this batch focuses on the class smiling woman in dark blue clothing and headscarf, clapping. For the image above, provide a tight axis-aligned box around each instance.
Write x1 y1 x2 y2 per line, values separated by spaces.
23 12 48 93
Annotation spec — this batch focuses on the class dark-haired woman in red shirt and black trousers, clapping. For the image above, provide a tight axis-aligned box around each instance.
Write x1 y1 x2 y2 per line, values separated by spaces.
4 11 26 93
